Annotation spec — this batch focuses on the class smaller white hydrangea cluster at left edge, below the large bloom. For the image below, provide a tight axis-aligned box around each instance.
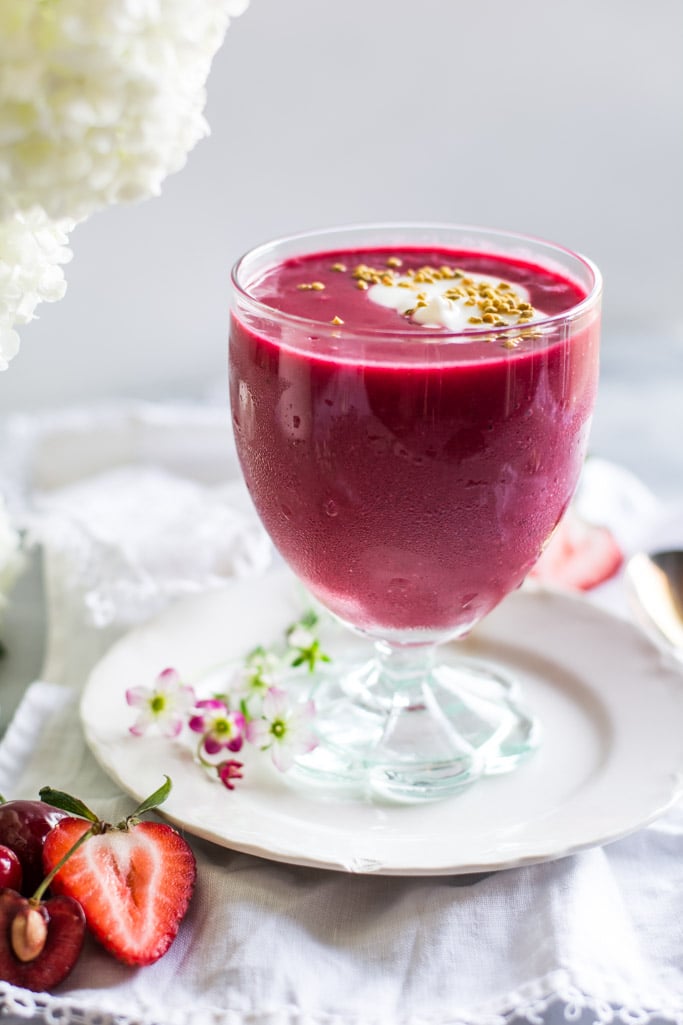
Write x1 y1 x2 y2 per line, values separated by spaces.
0 207 72 371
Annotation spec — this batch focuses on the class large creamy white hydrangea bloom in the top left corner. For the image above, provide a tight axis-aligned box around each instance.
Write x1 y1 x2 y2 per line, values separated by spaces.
0 0 248 220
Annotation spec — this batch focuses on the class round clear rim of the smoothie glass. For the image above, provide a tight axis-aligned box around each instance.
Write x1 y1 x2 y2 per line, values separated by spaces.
231 220 602 343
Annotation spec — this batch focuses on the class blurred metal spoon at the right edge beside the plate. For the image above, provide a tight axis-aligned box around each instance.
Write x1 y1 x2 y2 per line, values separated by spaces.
625 550 683 661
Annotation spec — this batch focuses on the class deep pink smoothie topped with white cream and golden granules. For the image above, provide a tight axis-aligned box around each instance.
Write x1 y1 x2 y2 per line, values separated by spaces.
230 247 599 637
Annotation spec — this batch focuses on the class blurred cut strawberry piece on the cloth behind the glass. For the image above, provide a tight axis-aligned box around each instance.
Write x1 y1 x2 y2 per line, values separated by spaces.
529 508 624 590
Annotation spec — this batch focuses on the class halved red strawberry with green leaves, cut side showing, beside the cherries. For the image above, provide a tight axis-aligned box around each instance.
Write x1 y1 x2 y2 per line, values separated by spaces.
40 777 197 965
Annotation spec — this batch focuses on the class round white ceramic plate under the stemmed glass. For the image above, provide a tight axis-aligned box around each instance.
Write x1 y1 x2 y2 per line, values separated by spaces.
81 573 683 875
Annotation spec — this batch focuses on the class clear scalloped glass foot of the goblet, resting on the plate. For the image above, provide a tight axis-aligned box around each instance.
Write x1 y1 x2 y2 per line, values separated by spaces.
295 652 540 802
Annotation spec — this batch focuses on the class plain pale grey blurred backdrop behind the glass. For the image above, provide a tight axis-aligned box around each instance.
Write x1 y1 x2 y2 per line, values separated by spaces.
0 0 683 489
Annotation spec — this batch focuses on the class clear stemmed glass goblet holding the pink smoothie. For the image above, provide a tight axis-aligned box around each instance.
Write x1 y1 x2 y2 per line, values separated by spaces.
230 224 601 801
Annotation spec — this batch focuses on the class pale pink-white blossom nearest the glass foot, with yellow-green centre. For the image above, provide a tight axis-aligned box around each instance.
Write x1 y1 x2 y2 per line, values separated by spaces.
246 687 318 772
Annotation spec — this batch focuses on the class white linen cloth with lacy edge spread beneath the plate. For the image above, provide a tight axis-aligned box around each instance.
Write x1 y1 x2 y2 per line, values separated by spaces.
0 407 683 1025
